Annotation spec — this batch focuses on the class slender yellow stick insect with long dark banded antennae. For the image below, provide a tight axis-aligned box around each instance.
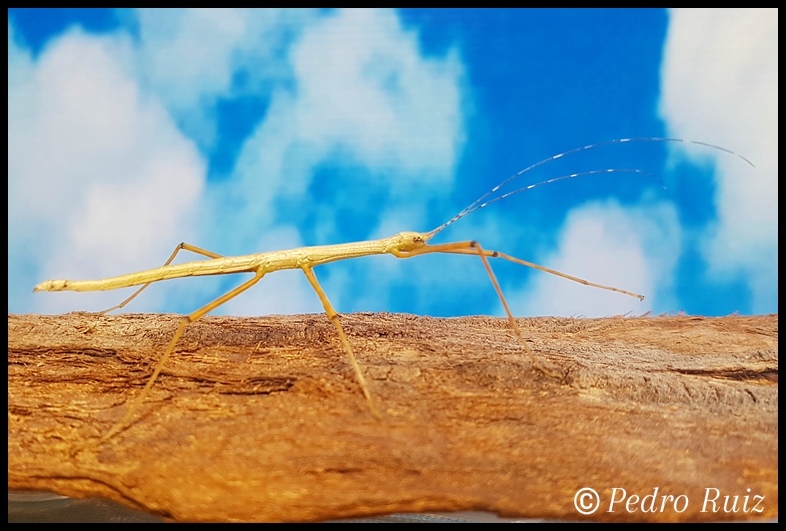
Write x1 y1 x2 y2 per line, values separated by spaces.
33 138 753 444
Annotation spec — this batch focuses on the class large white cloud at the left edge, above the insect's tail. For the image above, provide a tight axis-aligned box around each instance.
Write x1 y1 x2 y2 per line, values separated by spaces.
8 29 204 311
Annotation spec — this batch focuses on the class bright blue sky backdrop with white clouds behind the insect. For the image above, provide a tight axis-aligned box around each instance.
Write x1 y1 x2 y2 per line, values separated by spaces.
8 9 778 316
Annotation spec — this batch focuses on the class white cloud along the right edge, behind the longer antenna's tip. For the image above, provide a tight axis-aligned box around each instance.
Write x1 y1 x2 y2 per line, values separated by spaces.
661 9 778 312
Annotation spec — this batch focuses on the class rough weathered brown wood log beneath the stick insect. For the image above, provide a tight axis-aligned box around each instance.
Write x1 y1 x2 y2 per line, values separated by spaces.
8 314 778 521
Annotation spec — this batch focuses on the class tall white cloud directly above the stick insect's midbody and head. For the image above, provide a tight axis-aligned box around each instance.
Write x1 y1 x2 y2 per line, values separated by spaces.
211 10 464 260
